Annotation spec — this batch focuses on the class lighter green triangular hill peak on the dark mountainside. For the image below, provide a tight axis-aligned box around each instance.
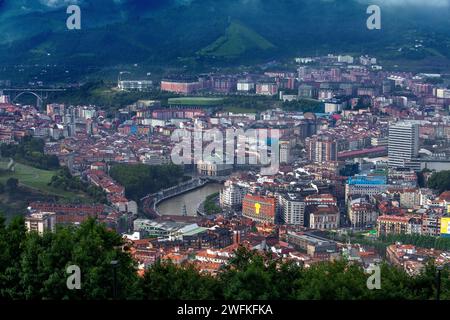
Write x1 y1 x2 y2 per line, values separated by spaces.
198 21 275 58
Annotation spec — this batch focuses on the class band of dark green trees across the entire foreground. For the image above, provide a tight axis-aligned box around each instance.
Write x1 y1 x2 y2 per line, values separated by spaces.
0 216 450 300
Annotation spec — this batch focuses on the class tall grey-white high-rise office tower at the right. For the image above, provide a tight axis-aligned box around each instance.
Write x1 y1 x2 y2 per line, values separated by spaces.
388 122 420 171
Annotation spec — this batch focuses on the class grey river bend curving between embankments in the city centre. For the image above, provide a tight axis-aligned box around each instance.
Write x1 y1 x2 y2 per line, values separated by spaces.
157 183 223 216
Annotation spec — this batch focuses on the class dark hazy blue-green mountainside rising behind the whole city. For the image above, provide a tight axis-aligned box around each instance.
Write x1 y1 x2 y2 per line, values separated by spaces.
0 0 450 75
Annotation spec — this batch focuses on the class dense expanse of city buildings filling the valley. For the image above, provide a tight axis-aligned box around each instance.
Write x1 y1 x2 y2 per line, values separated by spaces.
0 55 450 273
